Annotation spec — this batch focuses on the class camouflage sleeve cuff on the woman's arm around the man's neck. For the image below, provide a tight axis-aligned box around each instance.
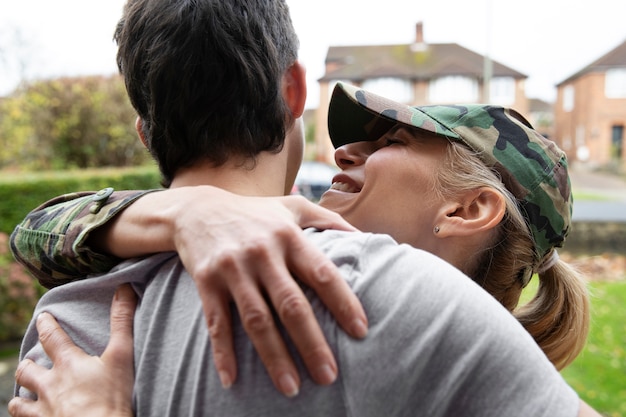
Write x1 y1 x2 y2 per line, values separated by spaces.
10 188 157 288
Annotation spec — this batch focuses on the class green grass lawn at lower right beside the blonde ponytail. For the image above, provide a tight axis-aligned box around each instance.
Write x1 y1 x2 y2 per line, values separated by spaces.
525 279 626 417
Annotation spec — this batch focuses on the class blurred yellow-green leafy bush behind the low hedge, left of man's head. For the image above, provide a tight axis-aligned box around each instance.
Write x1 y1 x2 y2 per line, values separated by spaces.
0 76 150 169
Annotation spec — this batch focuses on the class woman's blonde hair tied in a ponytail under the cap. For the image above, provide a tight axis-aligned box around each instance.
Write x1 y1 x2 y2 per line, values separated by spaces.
436 142 589 370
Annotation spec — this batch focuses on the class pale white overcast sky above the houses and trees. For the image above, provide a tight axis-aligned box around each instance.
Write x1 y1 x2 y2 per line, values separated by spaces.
0 0 626 108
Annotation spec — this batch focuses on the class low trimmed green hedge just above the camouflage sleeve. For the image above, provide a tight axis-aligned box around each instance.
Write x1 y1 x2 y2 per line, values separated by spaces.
0 166 160 234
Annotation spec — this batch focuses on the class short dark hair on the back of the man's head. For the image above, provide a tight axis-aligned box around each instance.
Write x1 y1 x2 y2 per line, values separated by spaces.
114 0 298 186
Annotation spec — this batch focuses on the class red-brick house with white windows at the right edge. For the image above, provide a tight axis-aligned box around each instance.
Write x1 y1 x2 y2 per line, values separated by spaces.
554 41 626 167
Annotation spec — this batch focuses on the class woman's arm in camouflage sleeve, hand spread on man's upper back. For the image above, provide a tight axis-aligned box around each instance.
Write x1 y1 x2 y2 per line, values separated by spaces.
12 186 367 394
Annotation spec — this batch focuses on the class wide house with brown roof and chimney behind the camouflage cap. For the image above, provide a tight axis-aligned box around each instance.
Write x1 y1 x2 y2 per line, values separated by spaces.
315 22 529 162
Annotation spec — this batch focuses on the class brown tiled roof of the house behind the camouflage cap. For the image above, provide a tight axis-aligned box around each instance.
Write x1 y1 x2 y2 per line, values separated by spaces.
321 43 528 81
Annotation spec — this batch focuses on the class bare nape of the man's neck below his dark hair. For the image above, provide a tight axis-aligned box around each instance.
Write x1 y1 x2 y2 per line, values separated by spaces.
171 153 286 196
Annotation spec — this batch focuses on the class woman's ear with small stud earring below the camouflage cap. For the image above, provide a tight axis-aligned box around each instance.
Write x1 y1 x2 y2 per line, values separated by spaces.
436 187 506 237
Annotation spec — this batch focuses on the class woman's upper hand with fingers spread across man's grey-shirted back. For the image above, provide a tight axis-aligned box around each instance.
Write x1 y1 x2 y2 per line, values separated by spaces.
175 196 367 396
